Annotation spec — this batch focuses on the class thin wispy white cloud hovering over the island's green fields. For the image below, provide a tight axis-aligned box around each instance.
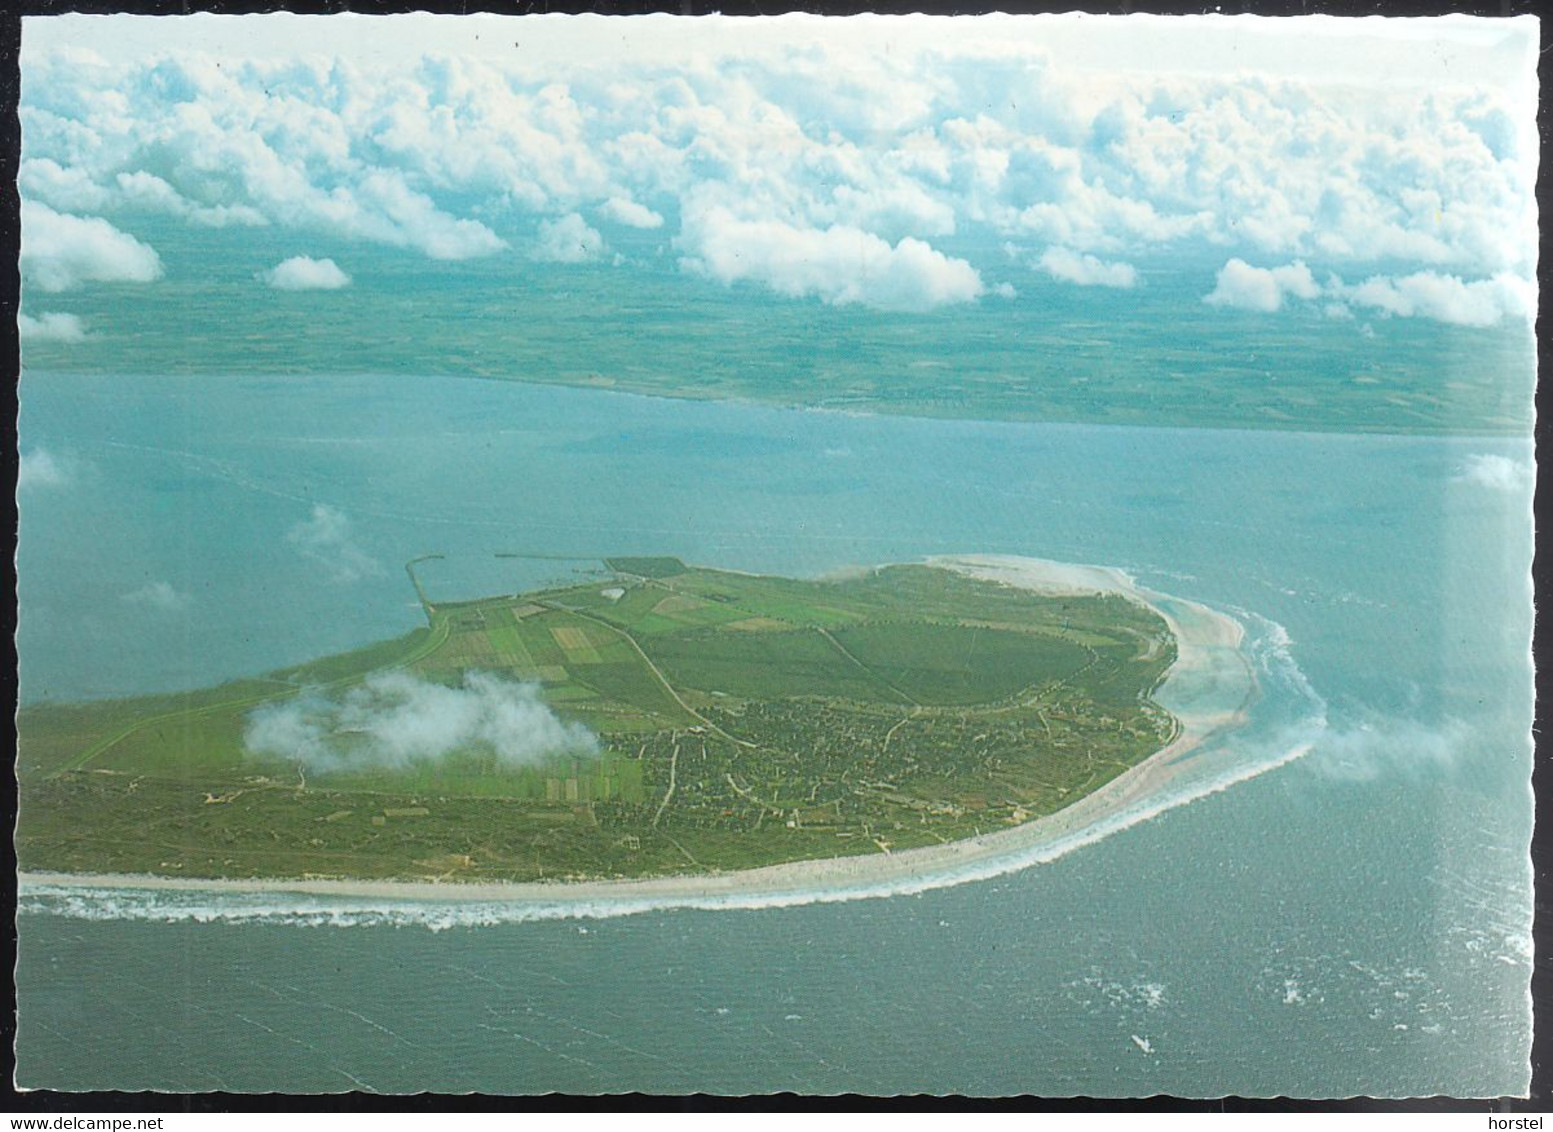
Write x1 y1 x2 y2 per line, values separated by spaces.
244 672 598 770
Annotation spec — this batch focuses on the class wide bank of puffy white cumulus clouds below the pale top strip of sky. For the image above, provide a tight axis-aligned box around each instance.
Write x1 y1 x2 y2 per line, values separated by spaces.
19 33 1539 307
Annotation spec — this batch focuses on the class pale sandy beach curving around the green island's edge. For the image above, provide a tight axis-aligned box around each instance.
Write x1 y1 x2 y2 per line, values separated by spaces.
19 556 1256 907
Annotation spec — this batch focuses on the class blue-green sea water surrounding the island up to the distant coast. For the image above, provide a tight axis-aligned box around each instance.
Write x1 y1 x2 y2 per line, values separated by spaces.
17 373 1531 1096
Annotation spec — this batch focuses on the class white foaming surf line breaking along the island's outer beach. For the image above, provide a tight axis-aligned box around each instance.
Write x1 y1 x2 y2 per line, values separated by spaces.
17 610 1328 932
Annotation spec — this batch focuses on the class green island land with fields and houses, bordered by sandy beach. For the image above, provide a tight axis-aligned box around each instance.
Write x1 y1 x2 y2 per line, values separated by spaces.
16 557 1176 880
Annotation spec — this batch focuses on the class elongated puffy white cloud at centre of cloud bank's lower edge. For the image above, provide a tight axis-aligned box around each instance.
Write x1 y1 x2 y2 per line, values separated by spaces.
682 208 985 311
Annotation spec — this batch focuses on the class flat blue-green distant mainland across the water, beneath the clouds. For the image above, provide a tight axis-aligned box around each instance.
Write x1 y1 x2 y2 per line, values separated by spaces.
23 225 1536 436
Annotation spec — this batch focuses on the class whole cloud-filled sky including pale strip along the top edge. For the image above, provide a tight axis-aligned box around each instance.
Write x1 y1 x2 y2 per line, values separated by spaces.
19 14 1537 329
